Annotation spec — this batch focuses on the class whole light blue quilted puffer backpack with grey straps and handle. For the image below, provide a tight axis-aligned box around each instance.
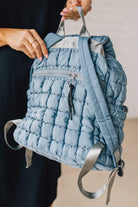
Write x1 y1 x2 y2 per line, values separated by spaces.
5 7 127 204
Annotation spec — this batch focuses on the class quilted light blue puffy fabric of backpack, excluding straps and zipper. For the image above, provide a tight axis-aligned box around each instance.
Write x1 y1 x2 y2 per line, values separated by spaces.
14 34 127 170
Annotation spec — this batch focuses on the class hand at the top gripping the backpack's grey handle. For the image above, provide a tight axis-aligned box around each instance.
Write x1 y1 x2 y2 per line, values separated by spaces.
60 0 92 21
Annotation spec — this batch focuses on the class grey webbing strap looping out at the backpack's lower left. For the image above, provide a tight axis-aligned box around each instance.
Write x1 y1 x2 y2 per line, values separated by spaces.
4 119 33 168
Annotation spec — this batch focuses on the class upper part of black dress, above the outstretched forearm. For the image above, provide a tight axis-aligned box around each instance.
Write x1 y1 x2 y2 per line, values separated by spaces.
0 0 66 38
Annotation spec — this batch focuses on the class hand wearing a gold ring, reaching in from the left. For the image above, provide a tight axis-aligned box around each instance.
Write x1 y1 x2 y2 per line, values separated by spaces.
0 28 48 61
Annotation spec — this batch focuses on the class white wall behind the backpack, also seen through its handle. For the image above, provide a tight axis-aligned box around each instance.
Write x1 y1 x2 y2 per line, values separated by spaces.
66 0 138 118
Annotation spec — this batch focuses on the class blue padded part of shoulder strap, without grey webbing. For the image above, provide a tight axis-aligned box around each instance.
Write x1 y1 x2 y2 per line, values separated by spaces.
79 37 118 167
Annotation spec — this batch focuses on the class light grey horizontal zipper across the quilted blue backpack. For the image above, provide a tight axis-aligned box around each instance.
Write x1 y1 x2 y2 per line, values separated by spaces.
32 70 83 80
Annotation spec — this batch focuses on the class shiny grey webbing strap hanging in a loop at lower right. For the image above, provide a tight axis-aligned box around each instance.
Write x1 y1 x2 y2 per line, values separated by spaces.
78 142 120 205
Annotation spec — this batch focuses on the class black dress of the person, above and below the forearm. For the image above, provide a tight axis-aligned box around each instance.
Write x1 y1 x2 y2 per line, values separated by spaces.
0 0 65 207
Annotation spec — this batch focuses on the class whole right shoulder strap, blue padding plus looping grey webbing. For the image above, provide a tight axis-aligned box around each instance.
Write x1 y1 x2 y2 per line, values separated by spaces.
78 37 124 205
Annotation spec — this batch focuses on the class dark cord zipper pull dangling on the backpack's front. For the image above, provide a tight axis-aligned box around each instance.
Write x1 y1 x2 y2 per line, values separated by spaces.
68 83 75 120
